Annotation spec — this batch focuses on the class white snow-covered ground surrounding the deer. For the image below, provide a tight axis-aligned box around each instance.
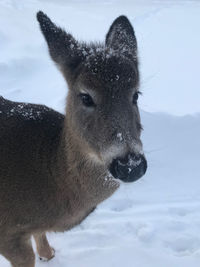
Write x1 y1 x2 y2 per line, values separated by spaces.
0 0 200 267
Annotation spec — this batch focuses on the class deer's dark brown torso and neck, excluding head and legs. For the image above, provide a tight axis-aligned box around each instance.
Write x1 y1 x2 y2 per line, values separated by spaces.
0 98 117 232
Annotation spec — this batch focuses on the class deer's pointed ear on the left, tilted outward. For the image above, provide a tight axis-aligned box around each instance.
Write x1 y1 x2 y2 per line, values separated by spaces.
37 11 82 79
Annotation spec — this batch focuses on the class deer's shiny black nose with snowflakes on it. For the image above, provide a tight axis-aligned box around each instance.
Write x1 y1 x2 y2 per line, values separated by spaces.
109 154 147 182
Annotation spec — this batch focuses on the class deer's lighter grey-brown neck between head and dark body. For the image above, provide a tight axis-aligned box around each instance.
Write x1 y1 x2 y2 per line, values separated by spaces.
57 118 119 207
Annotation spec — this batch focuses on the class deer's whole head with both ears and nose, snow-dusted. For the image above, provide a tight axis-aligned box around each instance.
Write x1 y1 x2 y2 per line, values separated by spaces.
38 12 147 182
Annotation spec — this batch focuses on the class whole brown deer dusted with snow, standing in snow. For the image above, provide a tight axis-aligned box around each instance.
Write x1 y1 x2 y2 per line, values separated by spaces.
0 11 147 267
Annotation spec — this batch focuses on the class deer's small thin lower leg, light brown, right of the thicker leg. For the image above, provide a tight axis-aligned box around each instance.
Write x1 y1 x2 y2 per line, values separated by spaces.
34 233 55 261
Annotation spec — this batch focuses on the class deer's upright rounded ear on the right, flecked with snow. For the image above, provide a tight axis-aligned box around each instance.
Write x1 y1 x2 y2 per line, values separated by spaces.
106 16 137 61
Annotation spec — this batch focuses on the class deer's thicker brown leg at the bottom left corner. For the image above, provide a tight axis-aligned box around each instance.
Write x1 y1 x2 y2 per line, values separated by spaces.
0 235 35 267
